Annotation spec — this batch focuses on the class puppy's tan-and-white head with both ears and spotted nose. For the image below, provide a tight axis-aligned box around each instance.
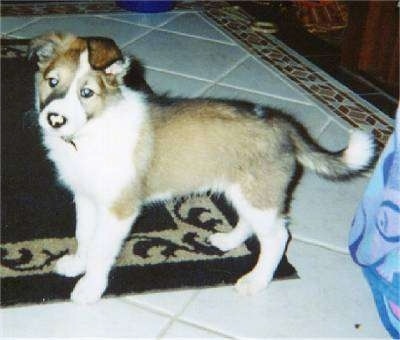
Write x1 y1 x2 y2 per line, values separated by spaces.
30 33 129 138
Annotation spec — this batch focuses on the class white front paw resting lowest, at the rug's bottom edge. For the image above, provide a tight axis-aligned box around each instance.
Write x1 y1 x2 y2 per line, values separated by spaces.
71 275 107 305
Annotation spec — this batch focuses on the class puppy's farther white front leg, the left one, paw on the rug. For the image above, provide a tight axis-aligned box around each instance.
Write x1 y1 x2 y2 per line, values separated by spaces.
55 194 97 277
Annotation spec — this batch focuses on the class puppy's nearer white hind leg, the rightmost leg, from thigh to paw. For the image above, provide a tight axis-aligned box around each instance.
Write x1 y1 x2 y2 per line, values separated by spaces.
228 185 288 295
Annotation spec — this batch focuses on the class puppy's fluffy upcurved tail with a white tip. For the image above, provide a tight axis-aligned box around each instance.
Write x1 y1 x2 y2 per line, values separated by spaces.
290 124 375 180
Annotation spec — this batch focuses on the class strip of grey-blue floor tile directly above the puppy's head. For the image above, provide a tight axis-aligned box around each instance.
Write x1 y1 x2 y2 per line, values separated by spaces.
15 16 149 45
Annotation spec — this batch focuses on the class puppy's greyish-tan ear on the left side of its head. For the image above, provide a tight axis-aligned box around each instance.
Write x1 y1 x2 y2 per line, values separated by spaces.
28 32 72 66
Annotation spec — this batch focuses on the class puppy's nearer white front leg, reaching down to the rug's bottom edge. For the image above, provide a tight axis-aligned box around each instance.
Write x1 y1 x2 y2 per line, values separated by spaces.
71 207 138 304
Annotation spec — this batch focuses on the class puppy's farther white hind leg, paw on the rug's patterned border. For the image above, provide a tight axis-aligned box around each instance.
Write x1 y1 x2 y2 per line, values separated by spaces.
209 218 253 251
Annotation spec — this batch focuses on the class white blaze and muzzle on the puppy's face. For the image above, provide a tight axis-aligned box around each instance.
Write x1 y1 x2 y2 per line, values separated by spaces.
39 50 91 138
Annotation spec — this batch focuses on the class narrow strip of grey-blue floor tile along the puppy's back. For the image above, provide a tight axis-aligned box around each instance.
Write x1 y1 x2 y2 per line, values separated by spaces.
202 85 328 137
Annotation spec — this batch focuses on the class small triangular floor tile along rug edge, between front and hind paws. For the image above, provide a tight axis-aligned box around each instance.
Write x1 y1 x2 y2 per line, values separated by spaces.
124 289 195 316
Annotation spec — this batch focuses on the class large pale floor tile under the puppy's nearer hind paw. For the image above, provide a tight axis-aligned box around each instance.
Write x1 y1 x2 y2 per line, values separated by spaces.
181 242 387 338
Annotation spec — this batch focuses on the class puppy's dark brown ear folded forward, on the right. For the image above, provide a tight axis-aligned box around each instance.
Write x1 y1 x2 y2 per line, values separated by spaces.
86 37 123 70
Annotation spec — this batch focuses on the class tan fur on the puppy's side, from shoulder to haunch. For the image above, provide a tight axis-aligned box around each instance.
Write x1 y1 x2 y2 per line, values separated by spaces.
141 101 294 212
